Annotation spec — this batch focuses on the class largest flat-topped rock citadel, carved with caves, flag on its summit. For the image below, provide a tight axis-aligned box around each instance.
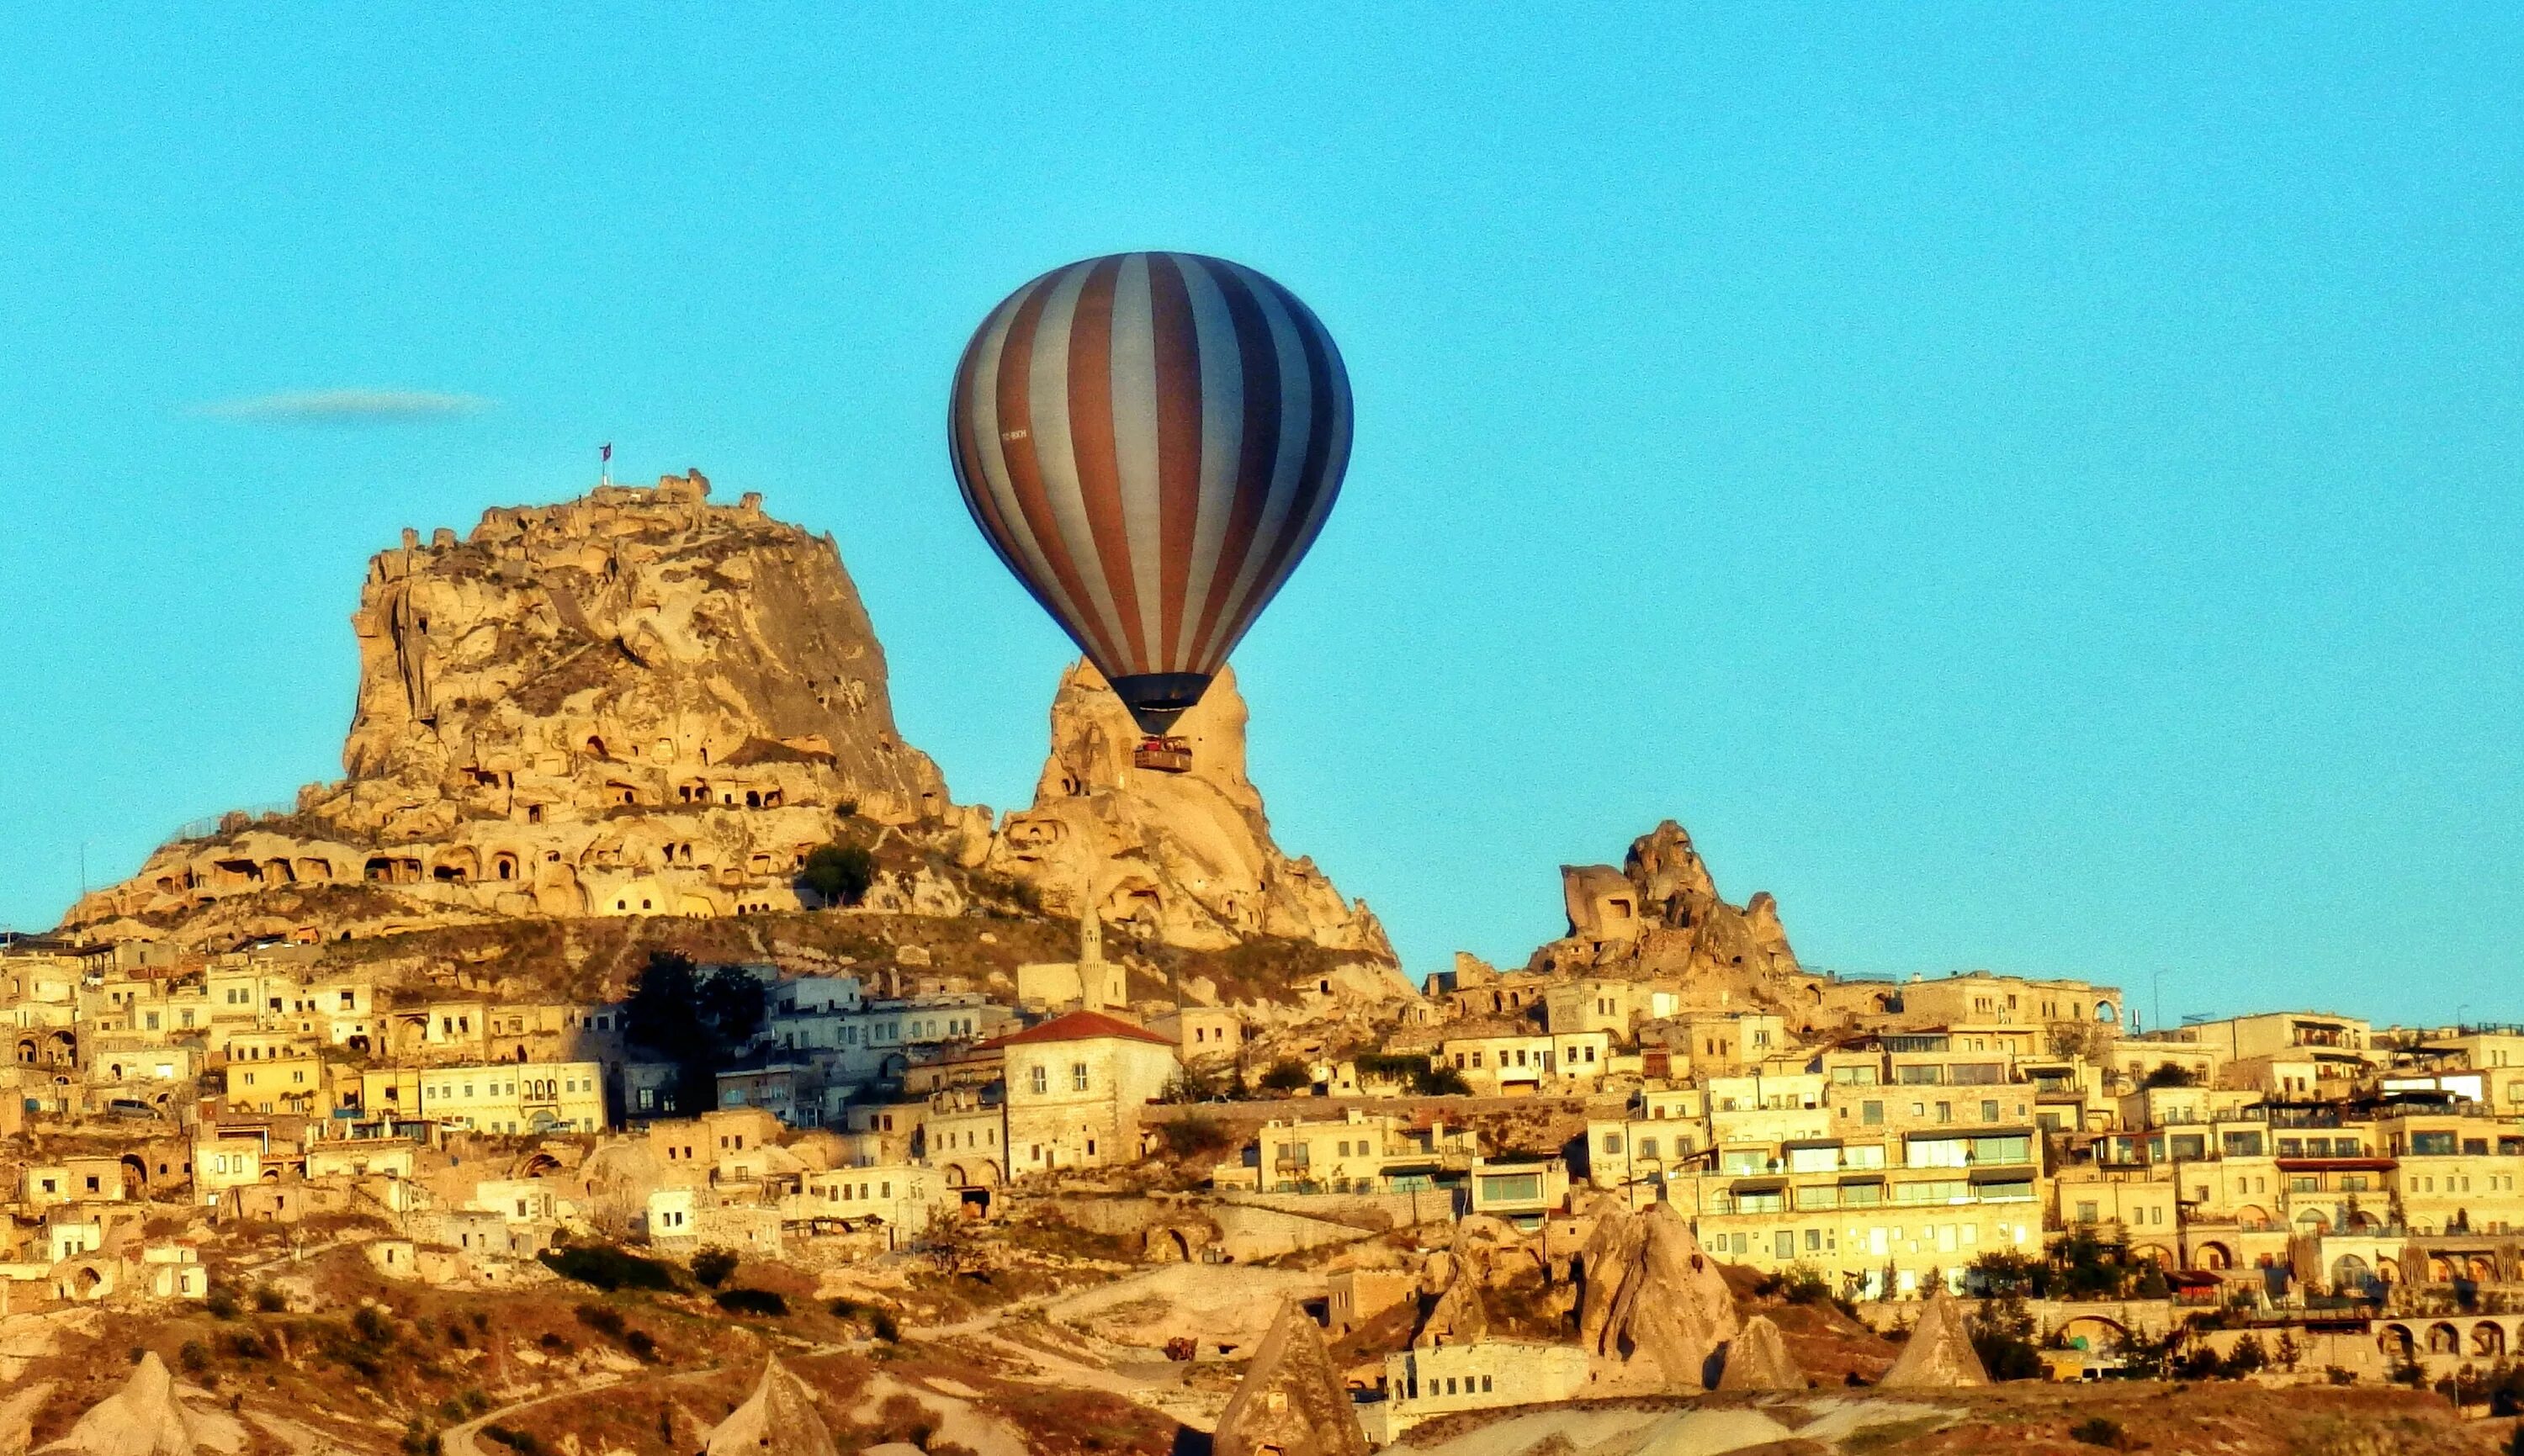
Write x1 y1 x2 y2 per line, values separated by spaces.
68 472 964 939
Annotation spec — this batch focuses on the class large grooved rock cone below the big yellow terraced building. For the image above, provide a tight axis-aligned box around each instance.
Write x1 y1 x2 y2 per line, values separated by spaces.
1578 1204 1739 1393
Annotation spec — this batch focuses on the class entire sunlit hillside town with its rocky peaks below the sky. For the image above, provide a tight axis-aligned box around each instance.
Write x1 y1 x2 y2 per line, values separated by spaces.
0 472 2524 1456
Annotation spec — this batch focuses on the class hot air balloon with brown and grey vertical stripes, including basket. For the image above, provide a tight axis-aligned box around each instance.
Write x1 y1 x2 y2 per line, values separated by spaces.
946 252 1350 772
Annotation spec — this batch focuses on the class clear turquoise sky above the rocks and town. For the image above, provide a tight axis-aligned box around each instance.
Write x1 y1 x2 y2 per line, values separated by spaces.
0 5 2524 1019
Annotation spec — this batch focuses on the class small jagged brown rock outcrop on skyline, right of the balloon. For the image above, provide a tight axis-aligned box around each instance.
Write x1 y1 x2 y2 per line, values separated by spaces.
1535 820 1800 1004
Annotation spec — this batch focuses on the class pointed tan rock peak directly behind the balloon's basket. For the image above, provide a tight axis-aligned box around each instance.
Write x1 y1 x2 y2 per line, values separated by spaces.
989 661 1393 961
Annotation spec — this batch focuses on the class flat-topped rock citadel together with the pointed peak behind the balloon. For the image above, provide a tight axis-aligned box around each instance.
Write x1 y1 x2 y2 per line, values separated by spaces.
63 472 1391 961
